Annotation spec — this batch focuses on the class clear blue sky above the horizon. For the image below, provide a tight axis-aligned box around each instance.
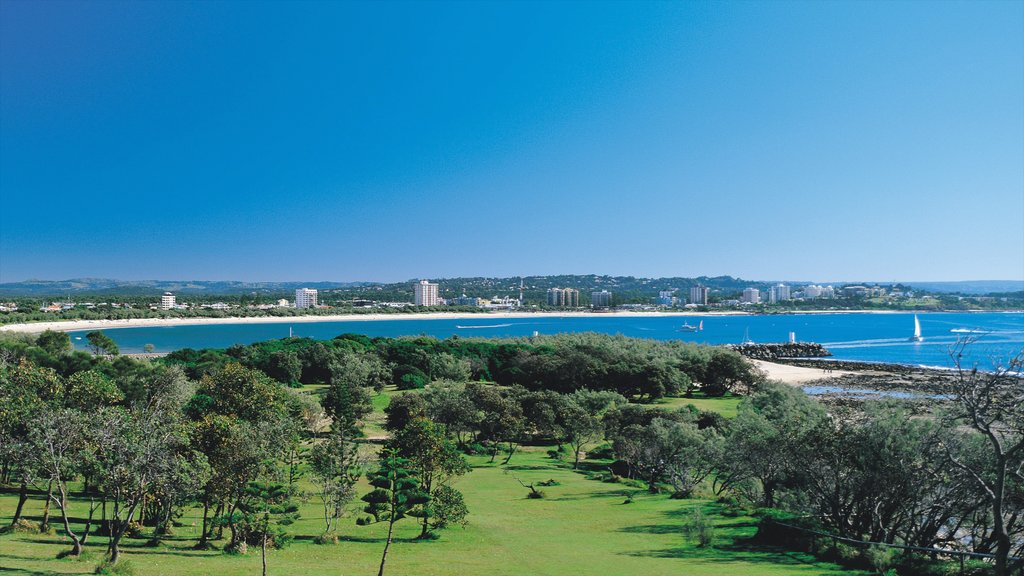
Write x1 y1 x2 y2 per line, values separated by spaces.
0 0 1024 282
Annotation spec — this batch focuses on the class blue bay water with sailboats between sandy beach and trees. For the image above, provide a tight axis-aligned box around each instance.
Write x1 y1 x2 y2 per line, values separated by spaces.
71 313 1024 367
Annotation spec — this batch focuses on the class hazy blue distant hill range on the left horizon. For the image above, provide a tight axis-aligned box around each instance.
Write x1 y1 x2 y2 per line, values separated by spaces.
0 278 376 297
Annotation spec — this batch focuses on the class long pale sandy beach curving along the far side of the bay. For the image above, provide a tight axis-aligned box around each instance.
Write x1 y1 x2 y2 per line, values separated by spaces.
0 310 995 334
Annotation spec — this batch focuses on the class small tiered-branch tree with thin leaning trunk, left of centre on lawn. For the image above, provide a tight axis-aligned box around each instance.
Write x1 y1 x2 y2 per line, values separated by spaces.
362 449 430 576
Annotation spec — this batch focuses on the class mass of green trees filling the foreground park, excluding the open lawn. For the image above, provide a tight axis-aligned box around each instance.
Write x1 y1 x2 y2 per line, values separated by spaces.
0 333 1024 576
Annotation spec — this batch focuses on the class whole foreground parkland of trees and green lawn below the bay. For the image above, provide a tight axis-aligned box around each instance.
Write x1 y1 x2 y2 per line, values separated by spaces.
0 333 1024 576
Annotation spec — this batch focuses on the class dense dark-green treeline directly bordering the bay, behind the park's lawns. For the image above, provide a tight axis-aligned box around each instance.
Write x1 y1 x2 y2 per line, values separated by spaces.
164 333 759 401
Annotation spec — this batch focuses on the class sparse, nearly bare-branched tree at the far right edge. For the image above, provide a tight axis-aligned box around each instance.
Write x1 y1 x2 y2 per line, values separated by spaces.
946 338 1024 576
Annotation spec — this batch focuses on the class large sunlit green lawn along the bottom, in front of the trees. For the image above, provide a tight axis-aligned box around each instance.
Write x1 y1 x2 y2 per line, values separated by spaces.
0 448 863 576
